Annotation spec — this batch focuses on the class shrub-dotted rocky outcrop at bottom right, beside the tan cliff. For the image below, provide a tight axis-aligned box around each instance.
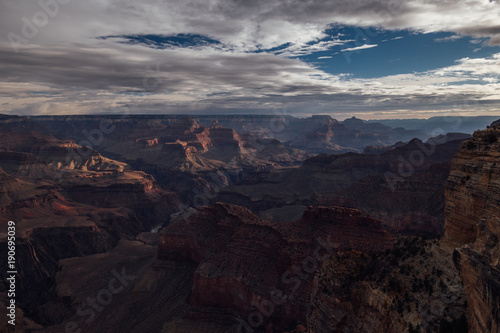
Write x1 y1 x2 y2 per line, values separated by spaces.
307 237 467 333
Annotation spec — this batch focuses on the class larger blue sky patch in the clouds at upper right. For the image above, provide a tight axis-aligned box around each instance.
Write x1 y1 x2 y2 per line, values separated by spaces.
299 27 500 78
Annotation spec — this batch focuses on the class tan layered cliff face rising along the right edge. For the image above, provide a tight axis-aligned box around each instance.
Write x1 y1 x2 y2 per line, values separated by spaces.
445 123 500 332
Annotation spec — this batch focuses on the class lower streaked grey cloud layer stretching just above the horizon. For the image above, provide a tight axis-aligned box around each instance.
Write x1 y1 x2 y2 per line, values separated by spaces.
0 34 500 117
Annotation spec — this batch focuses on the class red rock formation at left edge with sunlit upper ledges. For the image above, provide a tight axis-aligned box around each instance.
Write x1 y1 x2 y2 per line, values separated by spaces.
0 127 178 322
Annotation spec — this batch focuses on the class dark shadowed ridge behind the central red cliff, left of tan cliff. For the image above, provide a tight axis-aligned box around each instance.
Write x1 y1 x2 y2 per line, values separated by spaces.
214 139 462 237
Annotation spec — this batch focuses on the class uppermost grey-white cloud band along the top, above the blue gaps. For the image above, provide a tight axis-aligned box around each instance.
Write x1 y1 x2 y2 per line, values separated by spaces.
0 0 500 51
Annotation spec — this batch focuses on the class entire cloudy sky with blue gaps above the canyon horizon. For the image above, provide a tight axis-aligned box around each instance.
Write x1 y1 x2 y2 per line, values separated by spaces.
0 0 500 119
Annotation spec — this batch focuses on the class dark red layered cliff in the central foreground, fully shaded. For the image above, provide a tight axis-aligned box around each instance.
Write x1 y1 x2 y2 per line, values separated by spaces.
158 203 393 331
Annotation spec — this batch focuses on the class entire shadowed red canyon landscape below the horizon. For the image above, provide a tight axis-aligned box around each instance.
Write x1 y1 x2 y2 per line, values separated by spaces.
0 115 500 333
